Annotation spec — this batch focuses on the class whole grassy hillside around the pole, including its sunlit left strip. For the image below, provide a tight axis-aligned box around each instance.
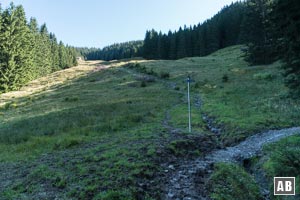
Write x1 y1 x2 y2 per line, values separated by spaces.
0 46 300 199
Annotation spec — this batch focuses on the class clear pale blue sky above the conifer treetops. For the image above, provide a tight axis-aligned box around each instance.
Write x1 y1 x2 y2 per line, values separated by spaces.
0 0 237 48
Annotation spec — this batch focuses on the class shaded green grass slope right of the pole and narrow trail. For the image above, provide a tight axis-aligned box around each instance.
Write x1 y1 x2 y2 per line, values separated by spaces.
129 46 300 143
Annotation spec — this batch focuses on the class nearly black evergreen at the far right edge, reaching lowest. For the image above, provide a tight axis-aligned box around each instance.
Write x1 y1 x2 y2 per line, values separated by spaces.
272 0 300 98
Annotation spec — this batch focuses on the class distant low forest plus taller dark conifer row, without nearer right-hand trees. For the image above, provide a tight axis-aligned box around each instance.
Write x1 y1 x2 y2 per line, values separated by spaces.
78 3 245 60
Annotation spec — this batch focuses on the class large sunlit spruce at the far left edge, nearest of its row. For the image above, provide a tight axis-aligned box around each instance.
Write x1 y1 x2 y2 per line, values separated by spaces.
0 3 33 91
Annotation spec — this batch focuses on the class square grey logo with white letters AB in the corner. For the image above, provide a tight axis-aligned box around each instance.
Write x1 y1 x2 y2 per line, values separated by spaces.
274 177 295 195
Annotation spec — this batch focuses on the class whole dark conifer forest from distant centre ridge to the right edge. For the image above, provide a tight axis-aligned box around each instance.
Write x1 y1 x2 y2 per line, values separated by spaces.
82 0 300 97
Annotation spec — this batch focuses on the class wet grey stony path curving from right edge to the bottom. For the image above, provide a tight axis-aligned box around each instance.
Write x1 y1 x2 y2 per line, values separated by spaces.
165 127 300 200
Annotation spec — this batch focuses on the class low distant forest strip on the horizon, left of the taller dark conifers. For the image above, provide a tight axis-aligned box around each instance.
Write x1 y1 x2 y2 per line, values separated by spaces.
77 41 143 61
